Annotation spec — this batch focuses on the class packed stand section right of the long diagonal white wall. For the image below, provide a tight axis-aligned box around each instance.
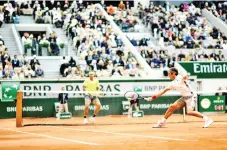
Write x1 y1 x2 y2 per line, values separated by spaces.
106 1 226 77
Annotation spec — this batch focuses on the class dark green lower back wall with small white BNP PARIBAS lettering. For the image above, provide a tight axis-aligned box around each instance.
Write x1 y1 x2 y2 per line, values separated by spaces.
0 96 182 119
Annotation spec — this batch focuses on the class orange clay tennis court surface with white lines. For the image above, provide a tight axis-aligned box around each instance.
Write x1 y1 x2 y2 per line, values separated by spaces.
0 114 227 150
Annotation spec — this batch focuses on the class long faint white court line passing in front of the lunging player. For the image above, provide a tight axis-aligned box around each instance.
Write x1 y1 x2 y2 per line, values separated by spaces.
54 127 198 142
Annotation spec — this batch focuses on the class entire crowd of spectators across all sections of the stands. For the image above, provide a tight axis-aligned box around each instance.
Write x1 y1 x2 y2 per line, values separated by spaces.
0 1 227 78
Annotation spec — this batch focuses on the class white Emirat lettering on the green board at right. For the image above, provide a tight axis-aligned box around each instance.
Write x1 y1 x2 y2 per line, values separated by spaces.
193 63 227 73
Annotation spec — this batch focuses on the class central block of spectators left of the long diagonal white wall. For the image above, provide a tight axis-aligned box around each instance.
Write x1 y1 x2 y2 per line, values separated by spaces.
57 4 147 77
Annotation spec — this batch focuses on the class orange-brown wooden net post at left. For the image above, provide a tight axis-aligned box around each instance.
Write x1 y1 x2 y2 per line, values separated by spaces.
16 91 23 127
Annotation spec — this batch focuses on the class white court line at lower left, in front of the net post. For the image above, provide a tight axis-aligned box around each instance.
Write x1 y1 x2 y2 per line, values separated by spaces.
0 128 100 145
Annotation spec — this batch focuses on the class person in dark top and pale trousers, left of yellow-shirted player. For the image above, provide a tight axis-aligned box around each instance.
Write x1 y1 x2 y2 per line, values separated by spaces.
57 87 69 119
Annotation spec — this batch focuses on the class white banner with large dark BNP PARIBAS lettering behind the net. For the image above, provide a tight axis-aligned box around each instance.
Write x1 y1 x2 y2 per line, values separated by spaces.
20 79 184 98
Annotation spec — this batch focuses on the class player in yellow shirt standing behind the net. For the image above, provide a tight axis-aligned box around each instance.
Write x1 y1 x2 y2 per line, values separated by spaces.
83 72 101 124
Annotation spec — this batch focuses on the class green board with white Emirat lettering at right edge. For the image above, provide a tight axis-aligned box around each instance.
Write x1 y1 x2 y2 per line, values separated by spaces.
179 62 227 79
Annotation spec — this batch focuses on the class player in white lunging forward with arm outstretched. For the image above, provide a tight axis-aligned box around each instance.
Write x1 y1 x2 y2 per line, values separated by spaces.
146 68 213 128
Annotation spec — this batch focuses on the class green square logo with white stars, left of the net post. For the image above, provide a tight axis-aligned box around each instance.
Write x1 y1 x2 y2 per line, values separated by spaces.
1 81 20 102
